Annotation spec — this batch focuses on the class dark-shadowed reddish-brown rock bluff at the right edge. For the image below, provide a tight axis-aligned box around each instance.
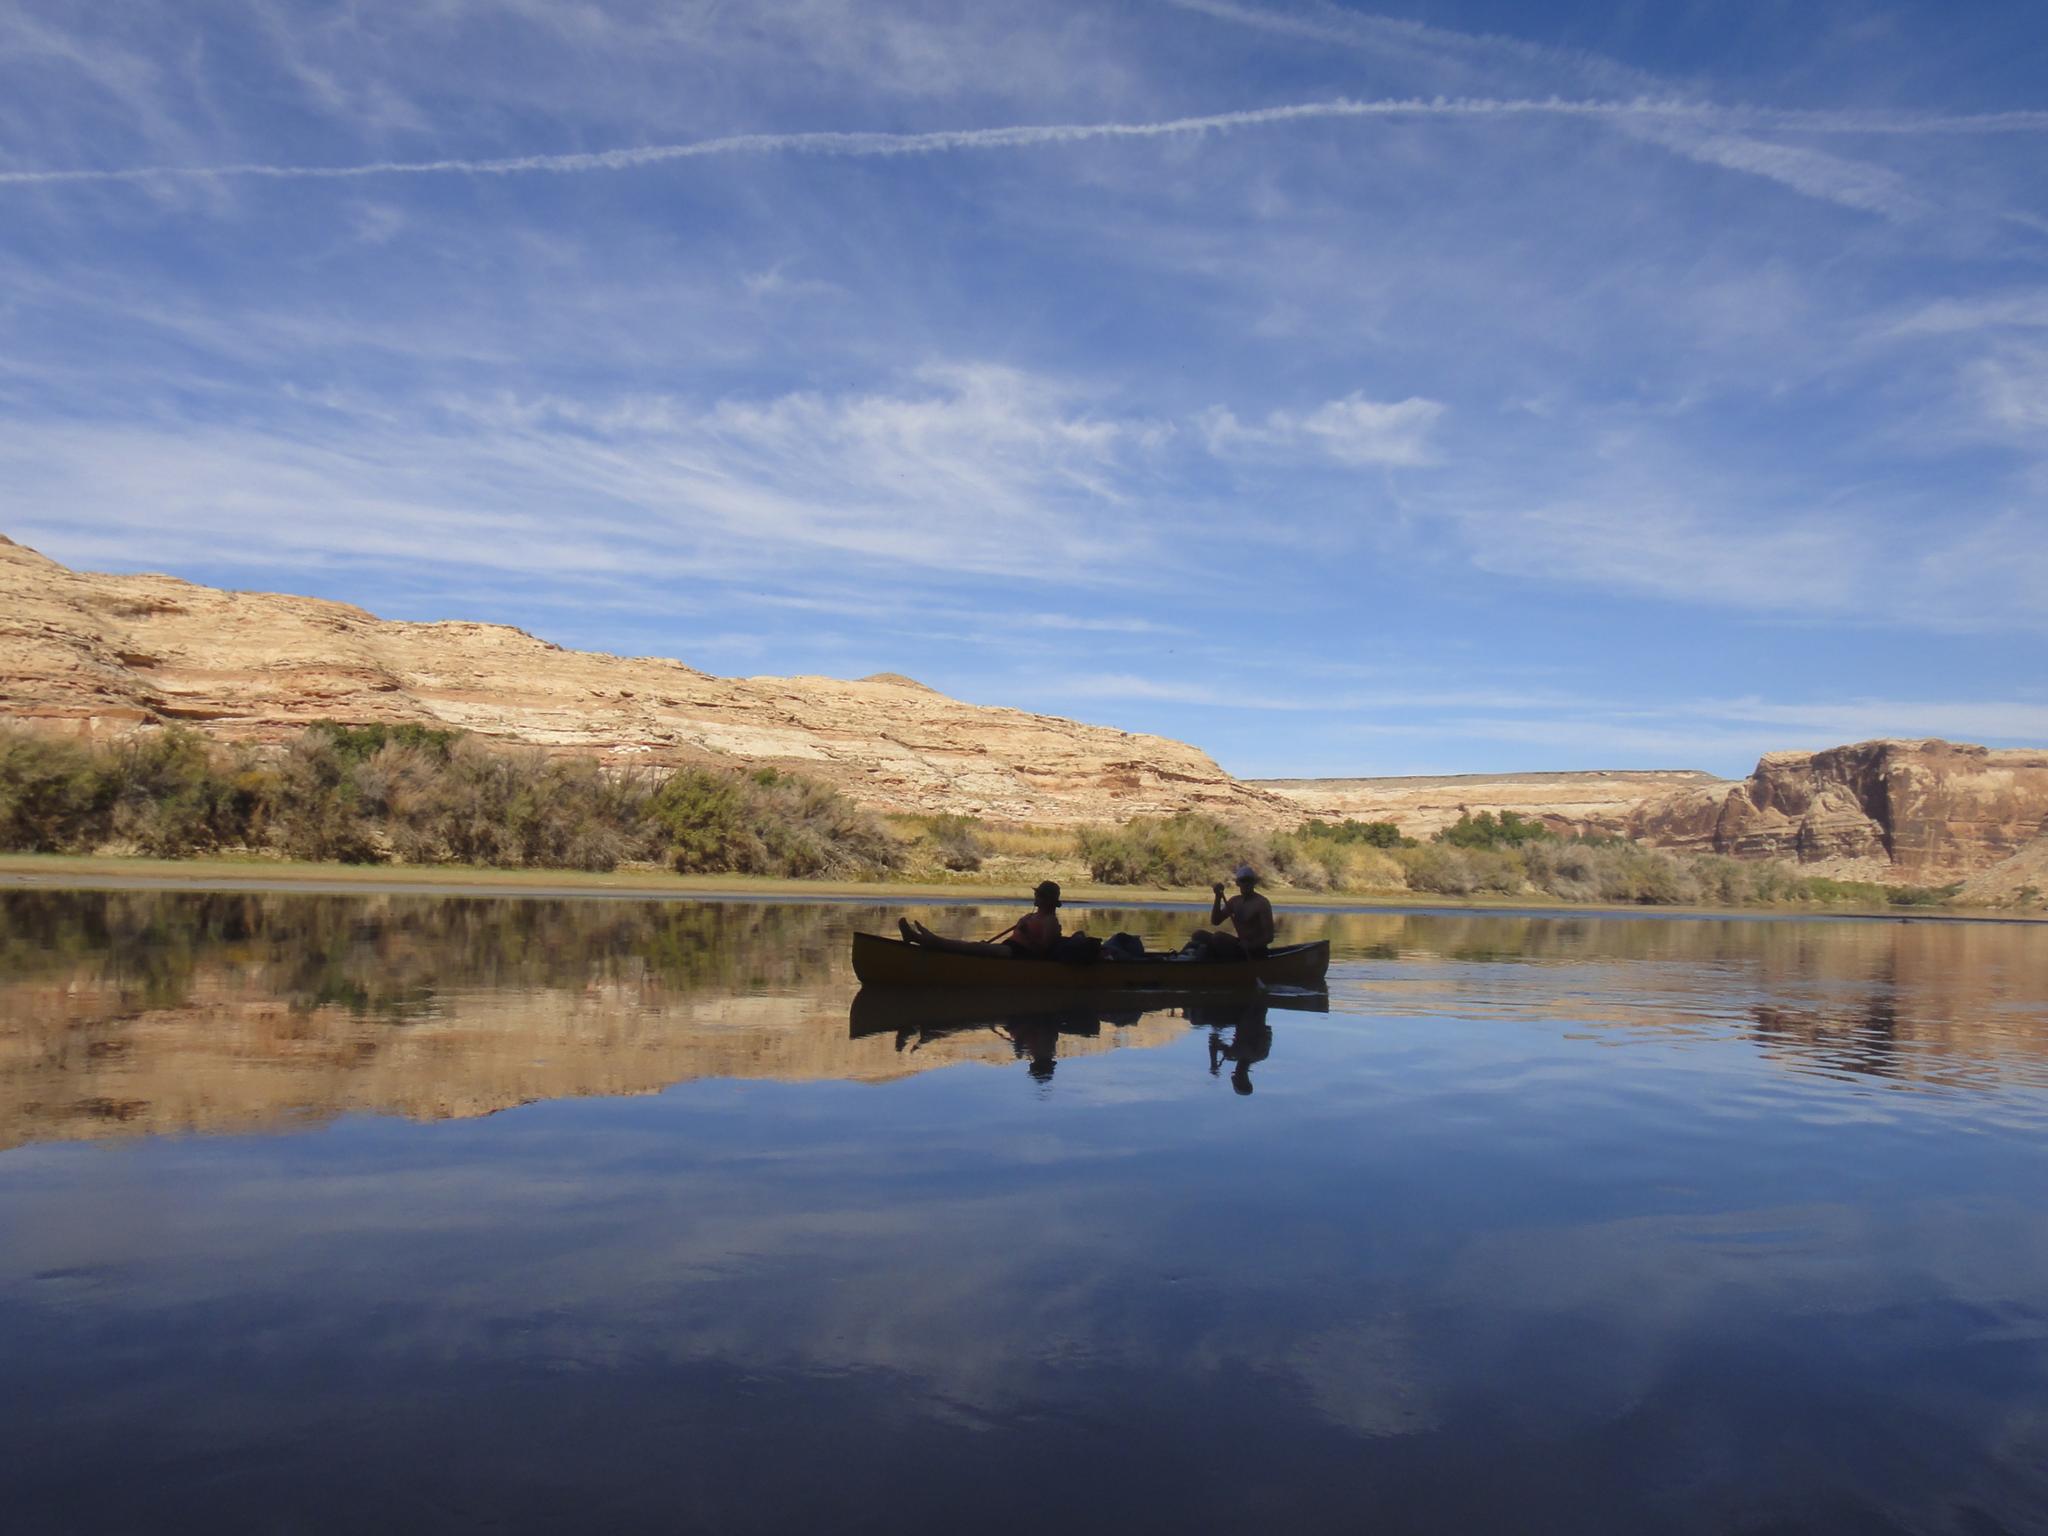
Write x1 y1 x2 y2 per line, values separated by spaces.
1626 741 2048 879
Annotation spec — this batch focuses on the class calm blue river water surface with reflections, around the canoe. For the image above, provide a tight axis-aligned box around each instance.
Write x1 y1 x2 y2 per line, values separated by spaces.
0 891 2048 1536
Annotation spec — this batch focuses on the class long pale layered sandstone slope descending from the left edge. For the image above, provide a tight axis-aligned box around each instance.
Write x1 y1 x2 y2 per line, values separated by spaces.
0 537 1296 825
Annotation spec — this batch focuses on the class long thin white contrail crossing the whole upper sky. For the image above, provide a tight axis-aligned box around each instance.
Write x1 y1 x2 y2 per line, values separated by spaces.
0 96 2048 186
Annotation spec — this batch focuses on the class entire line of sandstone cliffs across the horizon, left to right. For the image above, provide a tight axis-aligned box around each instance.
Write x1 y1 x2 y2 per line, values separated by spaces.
0 535 2048 887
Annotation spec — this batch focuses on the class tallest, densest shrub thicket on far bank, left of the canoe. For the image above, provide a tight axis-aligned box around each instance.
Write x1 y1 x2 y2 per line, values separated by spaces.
0 725 903 879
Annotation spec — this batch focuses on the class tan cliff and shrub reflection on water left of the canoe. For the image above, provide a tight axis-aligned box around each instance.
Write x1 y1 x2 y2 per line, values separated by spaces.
0 891 1212 1147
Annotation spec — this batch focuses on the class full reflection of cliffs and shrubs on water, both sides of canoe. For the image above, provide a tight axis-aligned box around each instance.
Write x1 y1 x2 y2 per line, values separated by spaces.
0 891 2048 1147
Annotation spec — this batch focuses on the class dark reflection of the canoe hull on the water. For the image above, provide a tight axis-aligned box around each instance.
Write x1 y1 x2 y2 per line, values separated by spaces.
846 987 1329 1040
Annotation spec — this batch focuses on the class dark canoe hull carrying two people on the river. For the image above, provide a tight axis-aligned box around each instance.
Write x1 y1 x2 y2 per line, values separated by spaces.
854 934 1329 991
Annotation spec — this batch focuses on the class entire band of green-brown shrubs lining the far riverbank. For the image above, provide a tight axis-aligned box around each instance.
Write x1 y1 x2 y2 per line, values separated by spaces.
0 723 1956 907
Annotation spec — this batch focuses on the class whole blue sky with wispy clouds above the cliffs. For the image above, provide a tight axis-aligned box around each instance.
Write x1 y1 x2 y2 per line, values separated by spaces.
0 0 2048 776
